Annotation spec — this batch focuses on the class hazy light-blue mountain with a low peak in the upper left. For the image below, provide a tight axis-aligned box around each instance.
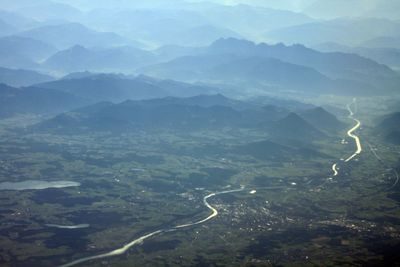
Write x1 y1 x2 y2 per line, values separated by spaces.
43 45 154 72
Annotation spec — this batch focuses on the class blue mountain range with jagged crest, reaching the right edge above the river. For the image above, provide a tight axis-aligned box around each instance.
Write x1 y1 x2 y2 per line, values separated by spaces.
138 38 400 94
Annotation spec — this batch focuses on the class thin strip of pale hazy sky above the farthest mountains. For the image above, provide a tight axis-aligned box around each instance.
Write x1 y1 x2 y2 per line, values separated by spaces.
4 0 400 19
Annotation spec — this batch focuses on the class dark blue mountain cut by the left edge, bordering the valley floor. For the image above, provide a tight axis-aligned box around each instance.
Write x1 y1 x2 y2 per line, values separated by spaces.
0 84 86 118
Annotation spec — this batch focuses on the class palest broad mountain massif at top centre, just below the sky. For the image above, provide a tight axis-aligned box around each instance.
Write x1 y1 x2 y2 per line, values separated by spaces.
77 1 313 47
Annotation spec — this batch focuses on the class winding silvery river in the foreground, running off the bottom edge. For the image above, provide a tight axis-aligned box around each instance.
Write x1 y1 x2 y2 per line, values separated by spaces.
60 187 244 267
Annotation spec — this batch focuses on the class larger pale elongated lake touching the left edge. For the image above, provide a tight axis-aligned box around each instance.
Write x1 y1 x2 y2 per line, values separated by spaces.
0 180 81 191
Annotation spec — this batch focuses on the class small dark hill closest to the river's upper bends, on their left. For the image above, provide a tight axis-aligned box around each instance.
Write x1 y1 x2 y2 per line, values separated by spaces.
300 107 346 133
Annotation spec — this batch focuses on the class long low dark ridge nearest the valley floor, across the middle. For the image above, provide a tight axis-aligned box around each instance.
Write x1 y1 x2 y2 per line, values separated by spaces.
37 95 346 136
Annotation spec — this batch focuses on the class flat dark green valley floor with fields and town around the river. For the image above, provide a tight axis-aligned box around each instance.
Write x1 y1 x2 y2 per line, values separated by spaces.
0 99 400 266
